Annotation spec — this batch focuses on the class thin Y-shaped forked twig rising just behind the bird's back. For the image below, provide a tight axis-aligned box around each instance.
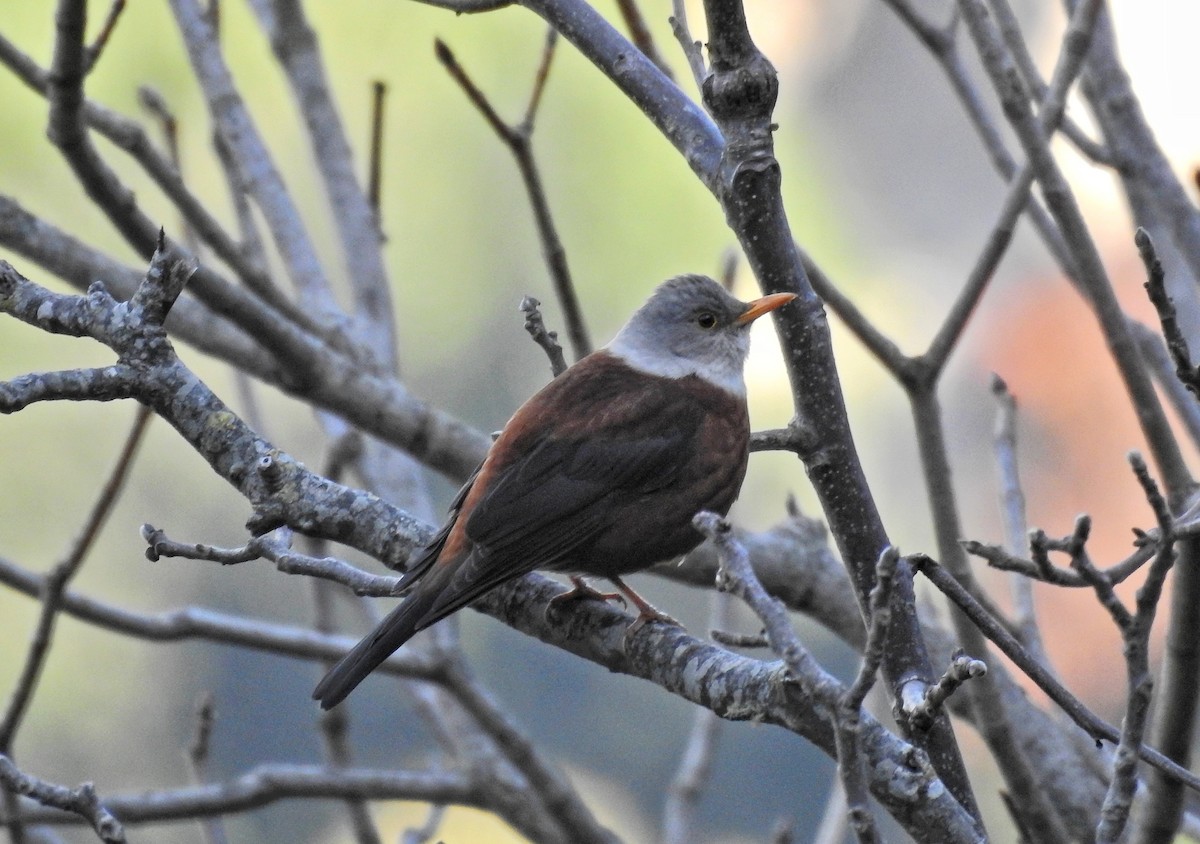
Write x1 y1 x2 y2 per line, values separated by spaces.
433 29 592 360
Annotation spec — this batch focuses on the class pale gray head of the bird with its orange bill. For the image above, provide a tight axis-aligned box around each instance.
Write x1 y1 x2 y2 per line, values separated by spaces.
605 275 796 395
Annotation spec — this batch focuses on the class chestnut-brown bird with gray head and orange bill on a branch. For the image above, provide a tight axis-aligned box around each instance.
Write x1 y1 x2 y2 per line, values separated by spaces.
313 275 796 710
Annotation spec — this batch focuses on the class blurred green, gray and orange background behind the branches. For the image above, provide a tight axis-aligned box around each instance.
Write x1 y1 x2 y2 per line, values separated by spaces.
0 0 1200 842
